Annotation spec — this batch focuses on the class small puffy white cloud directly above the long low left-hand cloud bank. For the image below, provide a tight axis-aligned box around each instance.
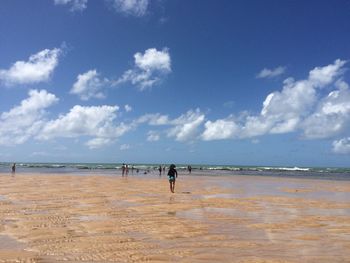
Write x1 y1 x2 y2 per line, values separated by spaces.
70 69 108 100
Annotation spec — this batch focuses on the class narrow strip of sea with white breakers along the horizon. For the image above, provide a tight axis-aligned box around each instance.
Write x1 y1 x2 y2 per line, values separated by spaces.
0 162 350 181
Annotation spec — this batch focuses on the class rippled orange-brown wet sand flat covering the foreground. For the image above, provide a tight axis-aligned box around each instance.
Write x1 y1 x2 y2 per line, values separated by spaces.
0 174 350 262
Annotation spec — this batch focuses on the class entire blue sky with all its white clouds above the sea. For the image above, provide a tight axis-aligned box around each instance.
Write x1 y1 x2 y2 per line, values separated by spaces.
0 0 350 166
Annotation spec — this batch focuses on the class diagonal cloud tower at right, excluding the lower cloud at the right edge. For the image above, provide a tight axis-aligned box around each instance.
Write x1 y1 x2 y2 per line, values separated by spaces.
246 60 346 137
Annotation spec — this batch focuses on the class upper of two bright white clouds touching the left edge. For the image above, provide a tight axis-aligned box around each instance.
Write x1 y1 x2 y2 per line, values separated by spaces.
0 48 61 85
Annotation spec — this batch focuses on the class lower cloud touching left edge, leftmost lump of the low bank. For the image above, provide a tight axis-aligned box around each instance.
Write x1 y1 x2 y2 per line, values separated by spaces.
0 90 58 145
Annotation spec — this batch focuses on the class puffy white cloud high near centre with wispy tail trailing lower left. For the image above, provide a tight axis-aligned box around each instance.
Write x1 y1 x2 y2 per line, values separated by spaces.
114 48 171 91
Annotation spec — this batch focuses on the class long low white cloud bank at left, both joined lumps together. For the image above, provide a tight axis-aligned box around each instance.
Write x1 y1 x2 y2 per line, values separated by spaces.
0 90 136 149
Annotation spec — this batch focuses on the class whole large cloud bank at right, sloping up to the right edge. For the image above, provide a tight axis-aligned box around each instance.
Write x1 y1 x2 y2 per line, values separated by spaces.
201 59 350 140
